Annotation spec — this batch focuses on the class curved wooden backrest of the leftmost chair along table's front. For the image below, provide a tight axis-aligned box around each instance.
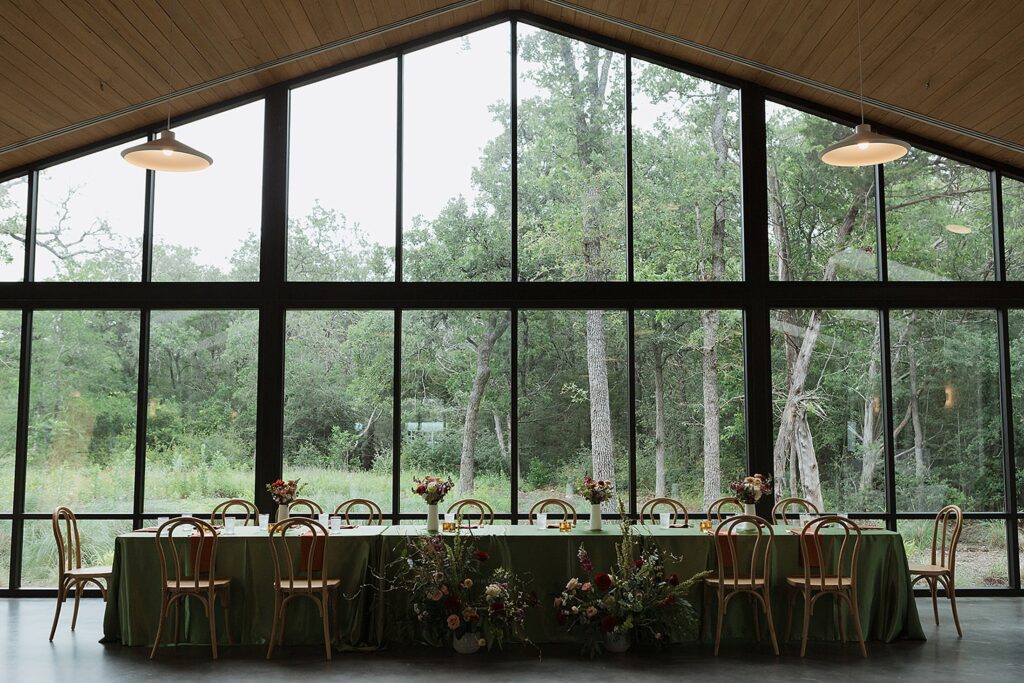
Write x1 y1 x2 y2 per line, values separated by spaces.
156 517 217 591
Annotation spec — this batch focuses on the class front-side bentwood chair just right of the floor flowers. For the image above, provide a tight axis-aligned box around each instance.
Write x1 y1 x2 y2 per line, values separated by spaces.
705 515 778 656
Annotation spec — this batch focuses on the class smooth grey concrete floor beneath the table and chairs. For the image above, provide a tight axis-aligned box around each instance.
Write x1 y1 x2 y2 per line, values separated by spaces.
0 598 1024 683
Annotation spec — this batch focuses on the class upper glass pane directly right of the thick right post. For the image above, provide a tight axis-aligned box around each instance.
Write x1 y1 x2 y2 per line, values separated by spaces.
765 101 878 281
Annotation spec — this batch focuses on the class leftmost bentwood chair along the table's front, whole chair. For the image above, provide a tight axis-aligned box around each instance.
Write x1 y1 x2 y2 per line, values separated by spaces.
150 517 231 659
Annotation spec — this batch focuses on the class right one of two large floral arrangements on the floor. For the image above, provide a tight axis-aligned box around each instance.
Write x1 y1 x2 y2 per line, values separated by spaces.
554 501 711 656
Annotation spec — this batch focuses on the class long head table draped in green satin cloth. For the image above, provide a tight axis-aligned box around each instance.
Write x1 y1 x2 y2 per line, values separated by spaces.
103 524 925 650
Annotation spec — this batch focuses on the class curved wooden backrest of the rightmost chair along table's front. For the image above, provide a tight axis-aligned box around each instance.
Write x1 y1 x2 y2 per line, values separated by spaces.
800 515 860 590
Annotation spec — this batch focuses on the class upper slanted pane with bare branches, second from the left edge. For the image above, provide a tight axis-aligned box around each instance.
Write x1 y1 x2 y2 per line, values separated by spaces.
36 144 145 282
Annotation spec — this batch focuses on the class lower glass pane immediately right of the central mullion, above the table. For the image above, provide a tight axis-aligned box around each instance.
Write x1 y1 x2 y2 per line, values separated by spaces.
518 310 629 513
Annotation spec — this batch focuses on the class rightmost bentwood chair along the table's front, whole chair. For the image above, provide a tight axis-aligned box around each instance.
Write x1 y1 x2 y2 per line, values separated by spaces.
785 515 867 657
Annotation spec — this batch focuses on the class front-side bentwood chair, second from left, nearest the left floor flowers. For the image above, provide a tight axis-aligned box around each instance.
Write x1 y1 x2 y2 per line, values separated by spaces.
266 517 341 659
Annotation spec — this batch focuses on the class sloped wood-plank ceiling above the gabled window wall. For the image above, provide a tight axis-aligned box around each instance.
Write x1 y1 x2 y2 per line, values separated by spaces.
0 0 1024 173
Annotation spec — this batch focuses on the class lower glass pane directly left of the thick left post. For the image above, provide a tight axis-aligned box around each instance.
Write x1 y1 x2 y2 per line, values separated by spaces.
144 310 259 514
